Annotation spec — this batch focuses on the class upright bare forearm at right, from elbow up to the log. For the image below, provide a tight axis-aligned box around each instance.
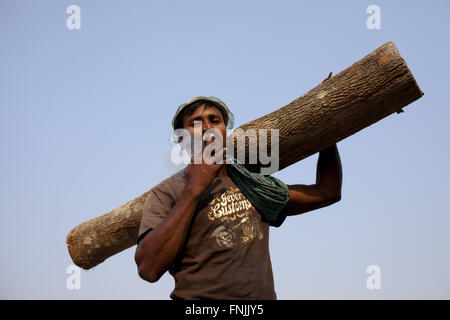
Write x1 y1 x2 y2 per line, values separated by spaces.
316 144 342 196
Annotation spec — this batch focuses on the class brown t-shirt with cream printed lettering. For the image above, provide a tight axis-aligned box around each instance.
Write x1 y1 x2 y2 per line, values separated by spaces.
138 169 276 299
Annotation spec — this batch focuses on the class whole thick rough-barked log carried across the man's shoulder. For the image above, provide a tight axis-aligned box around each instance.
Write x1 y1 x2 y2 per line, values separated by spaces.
66 42 423 269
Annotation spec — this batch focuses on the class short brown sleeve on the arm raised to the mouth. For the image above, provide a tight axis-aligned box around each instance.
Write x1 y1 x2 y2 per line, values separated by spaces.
137 185 175 243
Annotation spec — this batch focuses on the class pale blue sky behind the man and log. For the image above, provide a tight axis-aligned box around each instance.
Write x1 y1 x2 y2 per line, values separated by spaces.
0 0 450 299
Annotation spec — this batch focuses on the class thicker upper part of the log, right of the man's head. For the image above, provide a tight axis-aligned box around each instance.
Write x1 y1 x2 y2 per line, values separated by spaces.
235 42 423 172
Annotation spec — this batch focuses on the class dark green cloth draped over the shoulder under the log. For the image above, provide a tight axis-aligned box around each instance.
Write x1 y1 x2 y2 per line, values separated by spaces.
226 158 289 227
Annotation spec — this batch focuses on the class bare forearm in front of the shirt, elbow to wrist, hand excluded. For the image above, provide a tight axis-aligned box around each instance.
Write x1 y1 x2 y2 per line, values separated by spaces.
135 187 200 282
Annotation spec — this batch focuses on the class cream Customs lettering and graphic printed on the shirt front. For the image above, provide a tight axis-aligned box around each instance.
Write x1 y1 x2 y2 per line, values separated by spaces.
208 187 264 248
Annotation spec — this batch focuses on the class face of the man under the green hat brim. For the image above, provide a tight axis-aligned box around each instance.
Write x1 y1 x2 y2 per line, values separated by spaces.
183 104 227 156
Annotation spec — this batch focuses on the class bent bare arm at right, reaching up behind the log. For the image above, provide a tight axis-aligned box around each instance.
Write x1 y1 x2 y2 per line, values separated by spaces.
281 144 342 216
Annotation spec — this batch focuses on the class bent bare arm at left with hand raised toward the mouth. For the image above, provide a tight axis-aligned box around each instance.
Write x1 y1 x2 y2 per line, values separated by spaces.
134 148 223 282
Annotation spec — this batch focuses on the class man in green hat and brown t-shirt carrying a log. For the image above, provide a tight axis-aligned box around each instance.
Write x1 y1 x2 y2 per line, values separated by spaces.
135 97 342 299
